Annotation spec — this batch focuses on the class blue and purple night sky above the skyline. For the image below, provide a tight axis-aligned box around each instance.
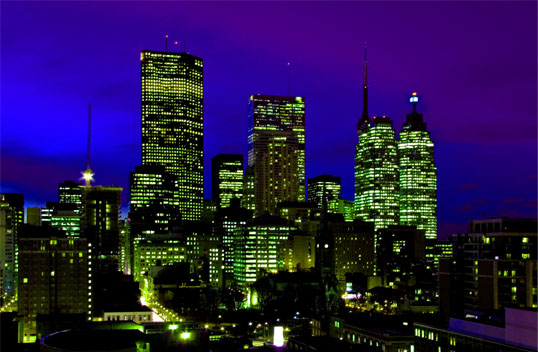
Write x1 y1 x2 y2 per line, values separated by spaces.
0 1 537 237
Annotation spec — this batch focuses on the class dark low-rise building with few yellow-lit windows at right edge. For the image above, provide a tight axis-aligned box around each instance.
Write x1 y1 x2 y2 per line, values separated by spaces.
439 218 538 320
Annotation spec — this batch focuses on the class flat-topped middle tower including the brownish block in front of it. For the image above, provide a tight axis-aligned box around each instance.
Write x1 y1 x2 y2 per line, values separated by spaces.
248 95 305 215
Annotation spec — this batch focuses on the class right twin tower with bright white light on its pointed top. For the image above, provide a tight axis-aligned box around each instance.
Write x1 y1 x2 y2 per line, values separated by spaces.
398 93 437 240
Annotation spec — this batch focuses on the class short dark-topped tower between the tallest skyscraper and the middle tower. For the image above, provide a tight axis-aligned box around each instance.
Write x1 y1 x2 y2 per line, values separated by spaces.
211 154 243 209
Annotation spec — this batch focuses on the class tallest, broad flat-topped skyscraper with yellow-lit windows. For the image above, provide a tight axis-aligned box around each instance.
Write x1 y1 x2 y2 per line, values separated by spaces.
141 50 204 220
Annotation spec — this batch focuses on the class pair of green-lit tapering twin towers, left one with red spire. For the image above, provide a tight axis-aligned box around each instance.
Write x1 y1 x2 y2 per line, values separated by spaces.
354 48 437 239
